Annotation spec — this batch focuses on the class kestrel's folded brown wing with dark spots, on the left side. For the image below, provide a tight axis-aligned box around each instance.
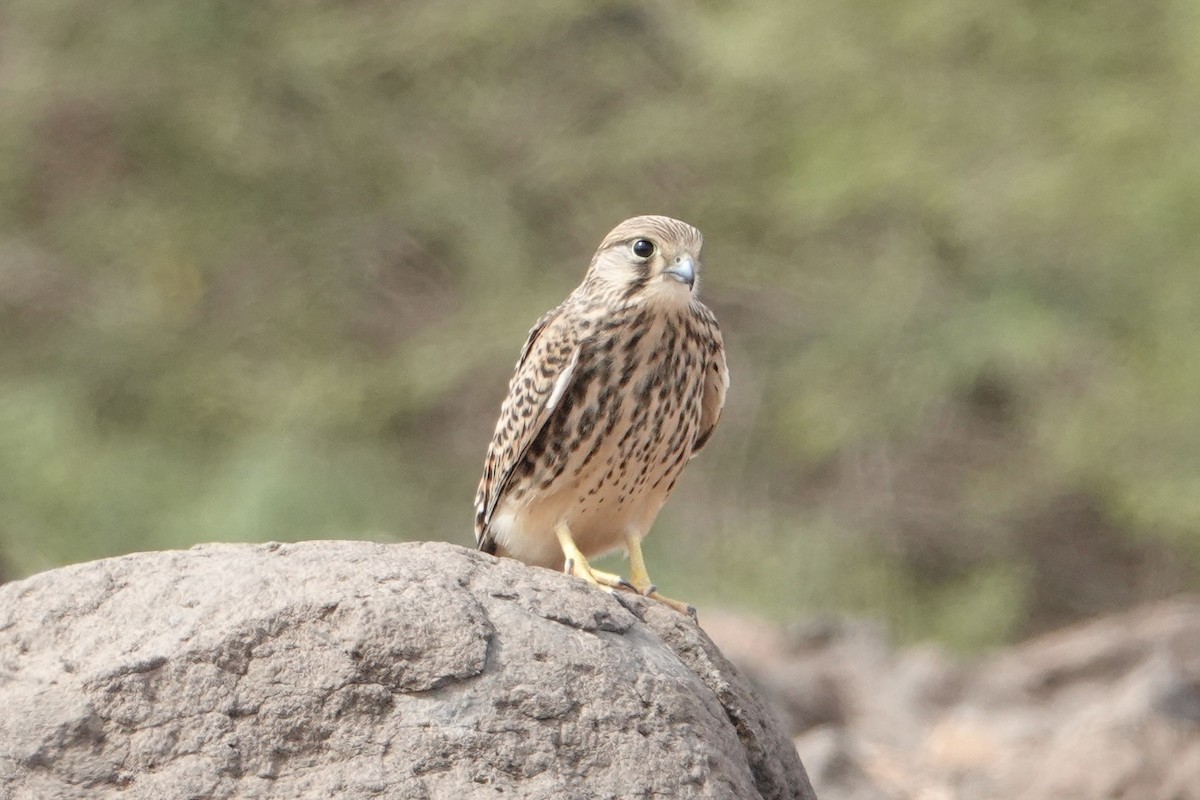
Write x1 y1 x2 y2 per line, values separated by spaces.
475 306 580 553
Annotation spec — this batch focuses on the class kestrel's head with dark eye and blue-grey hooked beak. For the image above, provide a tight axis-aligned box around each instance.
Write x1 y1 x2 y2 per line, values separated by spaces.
584 216 704 305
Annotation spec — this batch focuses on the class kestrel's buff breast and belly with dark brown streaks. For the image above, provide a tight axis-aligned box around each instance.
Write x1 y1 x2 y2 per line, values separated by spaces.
499 311 706 563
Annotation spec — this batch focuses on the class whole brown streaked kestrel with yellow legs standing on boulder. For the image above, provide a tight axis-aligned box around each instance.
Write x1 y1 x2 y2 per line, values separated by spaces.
475 216 730 614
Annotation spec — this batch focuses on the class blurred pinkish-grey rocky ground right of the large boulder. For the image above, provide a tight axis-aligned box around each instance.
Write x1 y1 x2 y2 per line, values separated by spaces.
706 596 1200 800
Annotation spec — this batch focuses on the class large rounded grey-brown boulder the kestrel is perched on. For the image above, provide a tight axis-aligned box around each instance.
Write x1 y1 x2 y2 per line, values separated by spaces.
0 542 814 800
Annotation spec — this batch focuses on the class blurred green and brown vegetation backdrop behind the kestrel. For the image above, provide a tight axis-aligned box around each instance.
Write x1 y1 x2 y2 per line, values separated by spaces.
0 0 1200 649
